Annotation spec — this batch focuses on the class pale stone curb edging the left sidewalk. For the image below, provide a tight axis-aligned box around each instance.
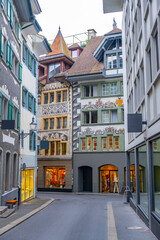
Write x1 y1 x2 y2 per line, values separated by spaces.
0 199 55 236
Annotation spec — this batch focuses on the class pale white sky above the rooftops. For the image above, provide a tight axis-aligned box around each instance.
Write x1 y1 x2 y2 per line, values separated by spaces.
36 0 122 43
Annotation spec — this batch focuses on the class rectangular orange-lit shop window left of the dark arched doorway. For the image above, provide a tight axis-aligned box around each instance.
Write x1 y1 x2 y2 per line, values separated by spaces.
45 167 66 188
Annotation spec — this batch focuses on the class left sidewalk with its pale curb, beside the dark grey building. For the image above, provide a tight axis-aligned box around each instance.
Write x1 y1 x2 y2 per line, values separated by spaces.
0 198 54 236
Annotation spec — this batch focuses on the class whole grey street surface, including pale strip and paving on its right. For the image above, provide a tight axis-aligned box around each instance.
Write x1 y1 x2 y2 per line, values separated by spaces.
0 193 156 240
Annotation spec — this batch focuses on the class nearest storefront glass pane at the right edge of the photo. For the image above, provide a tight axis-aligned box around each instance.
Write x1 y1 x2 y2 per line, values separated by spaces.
152 139 160 217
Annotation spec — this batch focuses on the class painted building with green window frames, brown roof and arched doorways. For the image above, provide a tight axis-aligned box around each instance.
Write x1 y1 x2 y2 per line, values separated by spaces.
67 25 125 192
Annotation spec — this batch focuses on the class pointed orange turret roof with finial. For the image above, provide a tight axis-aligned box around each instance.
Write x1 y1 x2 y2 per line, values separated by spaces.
47 28 71 58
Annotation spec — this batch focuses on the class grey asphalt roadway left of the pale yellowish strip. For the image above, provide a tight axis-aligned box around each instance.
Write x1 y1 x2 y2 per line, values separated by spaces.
0 193 118 240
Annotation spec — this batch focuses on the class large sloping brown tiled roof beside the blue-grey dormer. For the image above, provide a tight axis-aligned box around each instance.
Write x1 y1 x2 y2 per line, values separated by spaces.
67 36 104 77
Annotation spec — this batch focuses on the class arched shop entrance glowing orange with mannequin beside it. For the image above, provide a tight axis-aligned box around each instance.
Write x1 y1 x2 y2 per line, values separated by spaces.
100 165 119 193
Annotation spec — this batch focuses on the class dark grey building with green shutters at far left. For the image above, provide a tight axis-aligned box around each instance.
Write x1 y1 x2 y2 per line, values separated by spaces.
0 0 21 205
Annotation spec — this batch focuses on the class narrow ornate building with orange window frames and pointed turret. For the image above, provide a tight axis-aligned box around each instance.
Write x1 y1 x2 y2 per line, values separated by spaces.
38 29 74 191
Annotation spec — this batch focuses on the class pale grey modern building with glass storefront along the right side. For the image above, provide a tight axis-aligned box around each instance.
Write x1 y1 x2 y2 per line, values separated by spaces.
104 0 160 239
